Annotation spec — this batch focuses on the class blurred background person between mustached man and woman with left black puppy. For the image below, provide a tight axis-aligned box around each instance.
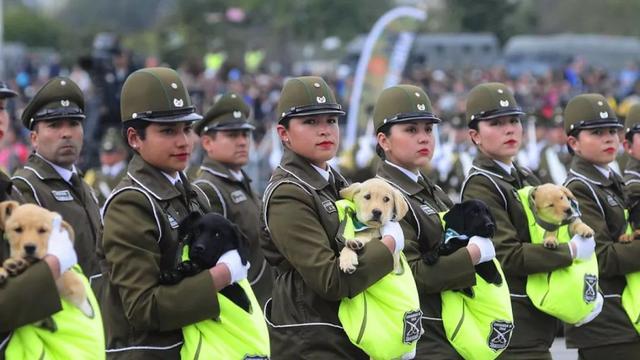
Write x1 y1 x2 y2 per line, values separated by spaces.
84 128 129 206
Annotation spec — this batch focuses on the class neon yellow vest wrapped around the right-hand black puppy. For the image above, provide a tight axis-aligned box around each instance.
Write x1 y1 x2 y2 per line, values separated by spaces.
439 212 513 360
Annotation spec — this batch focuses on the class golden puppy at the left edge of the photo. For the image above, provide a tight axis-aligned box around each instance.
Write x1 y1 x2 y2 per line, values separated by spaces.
0 201 93 316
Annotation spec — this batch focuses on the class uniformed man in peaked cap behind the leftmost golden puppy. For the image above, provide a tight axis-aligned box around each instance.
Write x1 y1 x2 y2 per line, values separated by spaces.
12 77 102 293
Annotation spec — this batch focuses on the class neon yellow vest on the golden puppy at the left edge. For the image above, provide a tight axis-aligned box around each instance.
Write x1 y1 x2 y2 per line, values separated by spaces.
5 265 105 360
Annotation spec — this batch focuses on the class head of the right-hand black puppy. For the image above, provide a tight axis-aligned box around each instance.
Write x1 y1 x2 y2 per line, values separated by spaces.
443 199 496 238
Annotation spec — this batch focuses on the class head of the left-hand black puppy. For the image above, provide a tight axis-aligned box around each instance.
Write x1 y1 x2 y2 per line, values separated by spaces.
189 213 249 268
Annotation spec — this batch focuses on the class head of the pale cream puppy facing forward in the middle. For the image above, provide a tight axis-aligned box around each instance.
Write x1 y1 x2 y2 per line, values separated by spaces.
340 178 409 228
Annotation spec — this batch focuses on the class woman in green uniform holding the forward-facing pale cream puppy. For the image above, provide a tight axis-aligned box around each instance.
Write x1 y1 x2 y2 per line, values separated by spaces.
261 77 404 359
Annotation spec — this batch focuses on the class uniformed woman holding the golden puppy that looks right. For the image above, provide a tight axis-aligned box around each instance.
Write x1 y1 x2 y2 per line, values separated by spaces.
461 83 572 359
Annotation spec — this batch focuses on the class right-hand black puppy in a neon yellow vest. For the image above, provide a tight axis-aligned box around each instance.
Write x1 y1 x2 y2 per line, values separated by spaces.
423 200 502 296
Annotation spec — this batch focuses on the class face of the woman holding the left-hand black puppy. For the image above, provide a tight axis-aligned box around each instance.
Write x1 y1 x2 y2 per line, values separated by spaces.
127 122 193 176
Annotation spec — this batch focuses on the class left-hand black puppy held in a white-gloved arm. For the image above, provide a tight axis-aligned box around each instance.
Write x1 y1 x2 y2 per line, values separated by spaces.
160 212 251 311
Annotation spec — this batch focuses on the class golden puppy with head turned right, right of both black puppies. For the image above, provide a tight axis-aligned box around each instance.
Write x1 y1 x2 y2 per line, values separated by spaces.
531 184 594 248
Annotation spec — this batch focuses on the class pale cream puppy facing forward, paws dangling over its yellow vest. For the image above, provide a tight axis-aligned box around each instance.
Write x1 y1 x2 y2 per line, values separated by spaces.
340 178 409 274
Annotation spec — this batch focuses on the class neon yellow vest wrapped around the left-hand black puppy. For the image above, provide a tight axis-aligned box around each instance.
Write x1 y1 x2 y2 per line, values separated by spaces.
180 246 271 360
